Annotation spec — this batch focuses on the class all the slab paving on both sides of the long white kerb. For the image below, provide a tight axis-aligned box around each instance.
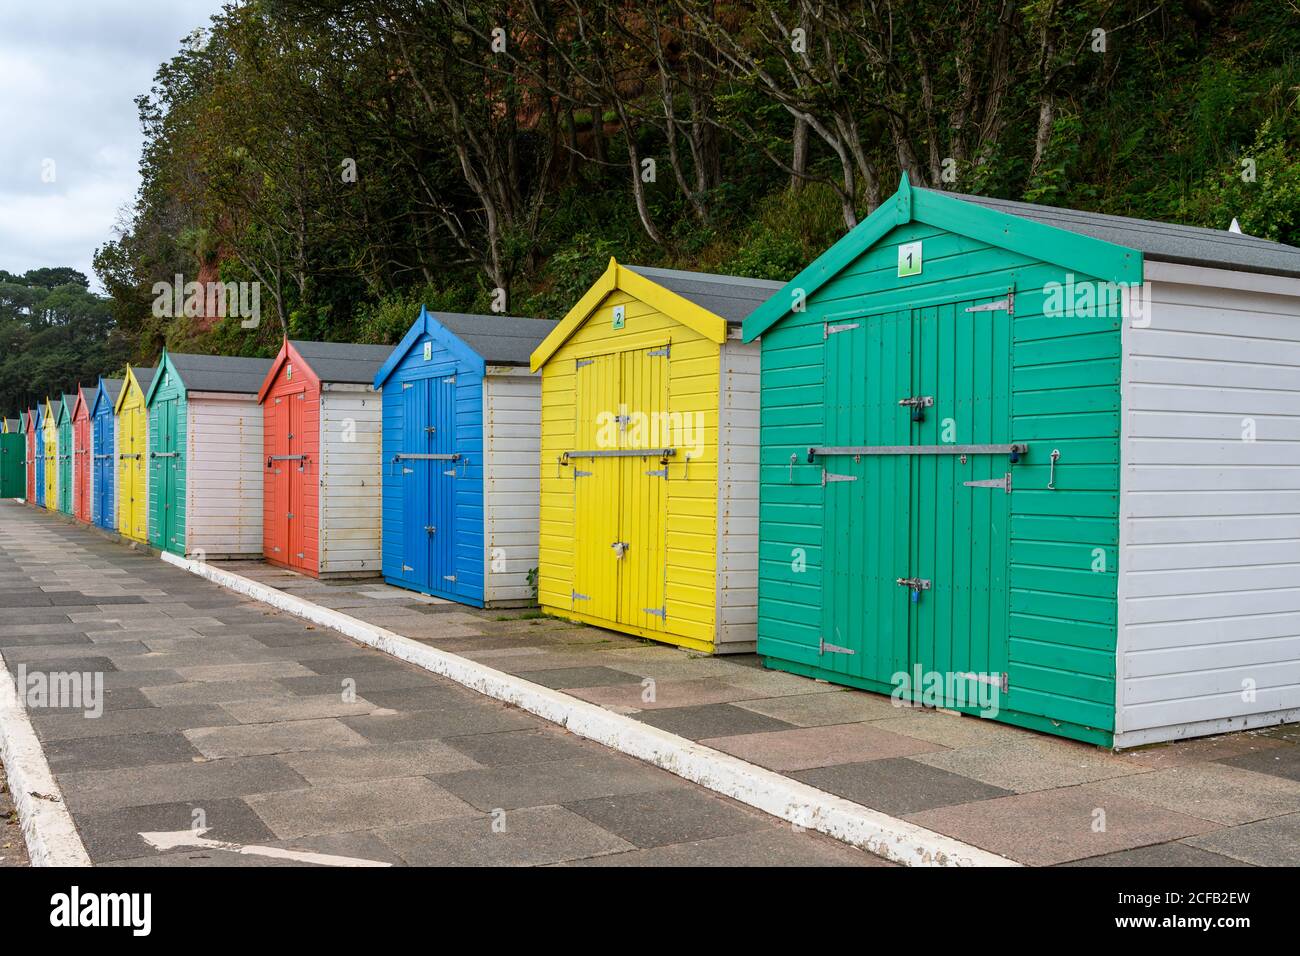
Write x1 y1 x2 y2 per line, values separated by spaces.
0 502 1300 866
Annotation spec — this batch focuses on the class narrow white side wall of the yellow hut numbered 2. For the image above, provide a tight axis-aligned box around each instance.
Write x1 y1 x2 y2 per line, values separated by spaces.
715 338 761 654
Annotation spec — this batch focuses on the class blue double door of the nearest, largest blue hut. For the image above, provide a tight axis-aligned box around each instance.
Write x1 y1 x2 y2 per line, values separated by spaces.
402 375 460 592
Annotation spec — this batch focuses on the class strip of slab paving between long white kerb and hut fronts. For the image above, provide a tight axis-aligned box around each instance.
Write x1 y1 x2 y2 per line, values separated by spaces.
213 561 1300 866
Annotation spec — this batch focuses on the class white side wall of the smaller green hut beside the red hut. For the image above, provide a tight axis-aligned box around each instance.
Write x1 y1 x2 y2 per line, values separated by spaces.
185 392 264 559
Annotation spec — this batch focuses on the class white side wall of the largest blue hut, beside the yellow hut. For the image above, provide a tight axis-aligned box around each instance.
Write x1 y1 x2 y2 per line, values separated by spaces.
482 365 542 606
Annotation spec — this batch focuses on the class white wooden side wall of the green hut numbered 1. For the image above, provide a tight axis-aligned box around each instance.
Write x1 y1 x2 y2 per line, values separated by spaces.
1112 263 1300 747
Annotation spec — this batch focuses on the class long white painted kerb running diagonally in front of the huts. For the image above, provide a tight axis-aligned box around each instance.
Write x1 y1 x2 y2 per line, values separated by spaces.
163 551 1019 866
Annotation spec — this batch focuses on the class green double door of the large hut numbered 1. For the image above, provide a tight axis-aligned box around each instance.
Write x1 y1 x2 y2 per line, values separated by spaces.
819 298 1014 706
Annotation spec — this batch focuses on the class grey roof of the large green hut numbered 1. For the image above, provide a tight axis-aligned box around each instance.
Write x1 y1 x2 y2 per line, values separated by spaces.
944 193 1300 277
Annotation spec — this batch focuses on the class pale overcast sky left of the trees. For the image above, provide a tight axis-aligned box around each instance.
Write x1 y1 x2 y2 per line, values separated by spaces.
0 0 221 287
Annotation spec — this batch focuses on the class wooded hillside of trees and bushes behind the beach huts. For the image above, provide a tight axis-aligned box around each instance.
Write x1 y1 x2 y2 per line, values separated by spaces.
0 0 1279 405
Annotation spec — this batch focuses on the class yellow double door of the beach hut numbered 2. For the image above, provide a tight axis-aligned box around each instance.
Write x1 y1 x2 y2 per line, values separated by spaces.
569 346 672 632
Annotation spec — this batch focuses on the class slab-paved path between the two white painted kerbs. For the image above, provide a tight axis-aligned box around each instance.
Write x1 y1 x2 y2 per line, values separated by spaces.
0 501 884 866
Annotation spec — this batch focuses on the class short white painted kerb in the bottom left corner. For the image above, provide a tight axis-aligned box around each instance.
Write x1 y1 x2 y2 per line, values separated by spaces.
0 659 90 866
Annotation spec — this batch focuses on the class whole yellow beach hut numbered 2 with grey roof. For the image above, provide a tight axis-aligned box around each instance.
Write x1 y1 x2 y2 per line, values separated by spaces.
532 259 781 653
